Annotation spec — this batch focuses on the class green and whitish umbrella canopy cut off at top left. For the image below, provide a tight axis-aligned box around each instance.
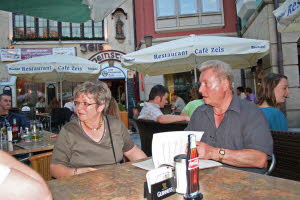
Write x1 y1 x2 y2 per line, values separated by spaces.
0 0 126 23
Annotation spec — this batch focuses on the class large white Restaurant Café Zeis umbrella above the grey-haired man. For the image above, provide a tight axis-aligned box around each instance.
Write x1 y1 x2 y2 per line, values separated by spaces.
121 35 269 81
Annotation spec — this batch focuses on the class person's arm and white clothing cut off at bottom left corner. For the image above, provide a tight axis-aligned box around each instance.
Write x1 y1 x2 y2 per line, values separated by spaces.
0 150 52 200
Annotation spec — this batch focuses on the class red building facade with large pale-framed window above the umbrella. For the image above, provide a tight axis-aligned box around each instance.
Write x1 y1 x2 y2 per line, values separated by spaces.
135 0 241 101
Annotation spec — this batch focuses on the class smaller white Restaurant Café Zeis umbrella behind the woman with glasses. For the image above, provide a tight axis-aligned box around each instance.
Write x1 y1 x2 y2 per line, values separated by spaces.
7 55 101 106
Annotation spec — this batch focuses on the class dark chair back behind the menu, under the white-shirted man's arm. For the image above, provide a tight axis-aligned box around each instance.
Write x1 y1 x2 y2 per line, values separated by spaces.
134 119 187 156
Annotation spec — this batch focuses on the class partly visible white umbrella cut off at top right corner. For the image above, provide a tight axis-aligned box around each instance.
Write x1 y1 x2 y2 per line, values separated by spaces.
273 0 300 32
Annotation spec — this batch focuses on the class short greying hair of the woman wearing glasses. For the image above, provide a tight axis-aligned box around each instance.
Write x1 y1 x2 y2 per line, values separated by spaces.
74 81 111 114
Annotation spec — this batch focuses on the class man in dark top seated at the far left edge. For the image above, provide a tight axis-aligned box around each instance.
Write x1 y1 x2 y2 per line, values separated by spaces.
0 93 29 127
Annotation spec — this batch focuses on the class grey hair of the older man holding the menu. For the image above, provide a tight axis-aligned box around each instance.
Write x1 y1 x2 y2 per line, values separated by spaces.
198 60 234 91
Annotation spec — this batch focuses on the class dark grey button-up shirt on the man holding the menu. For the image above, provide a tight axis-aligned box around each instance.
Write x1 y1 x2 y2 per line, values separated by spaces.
185 95 273 173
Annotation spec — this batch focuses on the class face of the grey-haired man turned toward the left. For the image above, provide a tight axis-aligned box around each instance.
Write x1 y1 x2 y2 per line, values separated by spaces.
199 69 226 106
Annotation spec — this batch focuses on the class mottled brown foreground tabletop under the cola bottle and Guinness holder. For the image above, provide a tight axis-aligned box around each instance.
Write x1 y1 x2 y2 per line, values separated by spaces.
48 163 300 200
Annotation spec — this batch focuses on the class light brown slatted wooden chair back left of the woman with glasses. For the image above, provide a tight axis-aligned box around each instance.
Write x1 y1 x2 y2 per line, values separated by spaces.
29 152 52 181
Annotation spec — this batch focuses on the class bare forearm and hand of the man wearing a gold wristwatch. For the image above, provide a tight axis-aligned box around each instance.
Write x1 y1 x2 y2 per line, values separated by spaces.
196 142 268 168
